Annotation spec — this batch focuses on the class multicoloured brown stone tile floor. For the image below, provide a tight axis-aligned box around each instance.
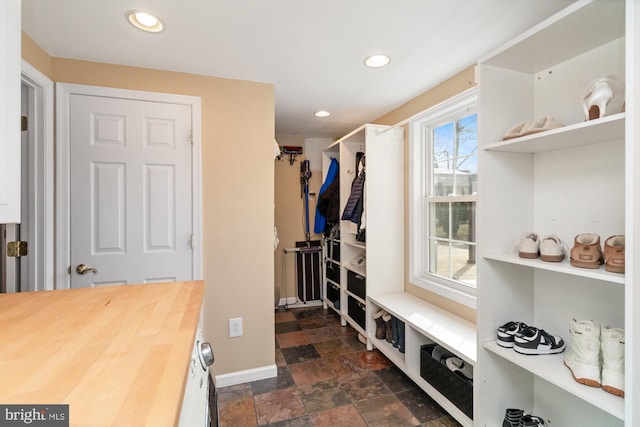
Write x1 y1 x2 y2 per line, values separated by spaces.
218 307 460 427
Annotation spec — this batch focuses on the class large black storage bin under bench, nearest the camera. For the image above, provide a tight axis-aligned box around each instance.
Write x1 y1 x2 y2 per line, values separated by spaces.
420 344 473 419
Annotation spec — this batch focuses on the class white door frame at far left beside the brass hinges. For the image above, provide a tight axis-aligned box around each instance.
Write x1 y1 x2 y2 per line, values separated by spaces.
22 60 55 291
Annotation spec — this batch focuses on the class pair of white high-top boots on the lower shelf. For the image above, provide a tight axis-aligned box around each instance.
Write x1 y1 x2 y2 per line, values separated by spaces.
564 319 624 397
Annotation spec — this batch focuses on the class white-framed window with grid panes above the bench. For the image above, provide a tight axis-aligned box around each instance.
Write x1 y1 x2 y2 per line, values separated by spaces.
409 89 478 307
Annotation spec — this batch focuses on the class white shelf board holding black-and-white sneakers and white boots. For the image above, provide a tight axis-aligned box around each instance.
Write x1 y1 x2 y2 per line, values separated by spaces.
483 341 624 420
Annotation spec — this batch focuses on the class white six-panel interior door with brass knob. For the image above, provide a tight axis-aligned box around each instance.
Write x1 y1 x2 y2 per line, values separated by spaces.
68 94 193 288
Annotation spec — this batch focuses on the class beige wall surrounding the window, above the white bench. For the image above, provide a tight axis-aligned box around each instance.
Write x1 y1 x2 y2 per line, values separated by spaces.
374 67 476 322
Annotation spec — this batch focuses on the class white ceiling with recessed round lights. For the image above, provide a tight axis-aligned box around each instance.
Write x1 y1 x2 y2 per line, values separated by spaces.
22 0 572 137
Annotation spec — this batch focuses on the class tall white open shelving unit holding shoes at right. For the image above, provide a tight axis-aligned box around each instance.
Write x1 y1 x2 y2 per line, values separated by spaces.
474 0 640 427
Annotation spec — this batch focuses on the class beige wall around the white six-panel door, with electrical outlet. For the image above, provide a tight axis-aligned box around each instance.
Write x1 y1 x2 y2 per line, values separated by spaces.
23 35 275 375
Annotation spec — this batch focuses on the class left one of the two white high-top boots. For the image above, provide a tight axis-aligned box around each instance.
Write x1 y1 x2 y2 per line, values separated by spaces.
564 319 600 387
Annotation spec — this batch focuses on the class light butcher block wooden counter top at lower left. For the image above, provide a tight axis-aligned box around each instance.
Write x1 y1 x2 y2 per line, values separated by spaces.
0 281 204 427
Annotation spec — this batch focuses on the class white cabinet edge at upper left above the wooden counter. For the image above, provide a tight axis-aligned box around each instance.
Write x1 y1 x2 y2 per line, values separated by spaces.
0 0 20 223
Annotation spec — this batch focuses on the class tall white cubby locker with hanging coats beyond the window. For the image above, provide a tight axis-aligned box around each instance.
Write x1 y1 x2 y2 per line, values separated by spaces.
324 124 404 340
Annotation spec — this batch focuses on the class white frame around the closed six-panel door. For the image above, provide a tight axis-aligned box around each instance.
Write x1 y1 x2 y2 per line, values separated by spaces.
56 83 202 289
